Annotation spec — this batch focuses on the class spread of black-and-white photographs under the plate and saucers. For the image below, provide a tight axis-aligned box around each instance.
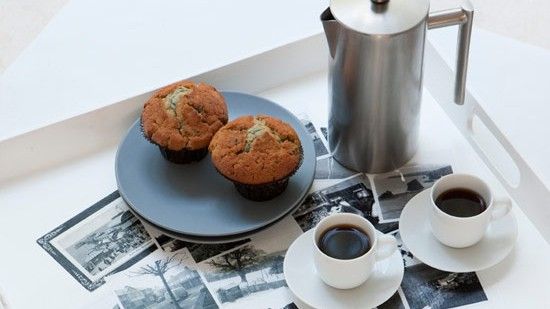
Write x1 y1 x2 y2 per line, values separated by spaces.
37 116 487 309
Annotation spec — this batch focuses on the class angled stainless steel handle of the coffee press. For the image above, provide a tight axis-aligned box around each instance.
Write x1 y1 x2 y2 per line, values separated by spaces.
428 0 474 105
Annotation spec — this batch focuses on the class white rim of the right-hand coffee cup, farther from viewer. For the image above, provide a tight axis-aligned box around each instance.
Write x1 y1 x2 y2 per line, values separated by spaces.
430 174 494 221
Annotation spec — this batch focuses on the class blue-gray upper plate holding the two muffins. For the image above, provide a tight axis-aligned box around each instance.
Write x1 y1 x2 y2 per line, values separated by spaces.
115 92 316 238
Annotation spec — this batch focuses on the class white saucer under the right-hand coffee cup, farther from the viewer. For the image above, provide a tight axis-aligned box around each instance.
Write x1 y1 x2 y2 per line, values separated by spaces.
399 189 518 272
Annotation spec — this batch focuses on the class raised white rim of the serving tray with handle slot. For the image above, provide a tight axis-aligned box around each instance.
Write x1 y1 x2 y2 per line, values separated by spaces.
0 31 550 243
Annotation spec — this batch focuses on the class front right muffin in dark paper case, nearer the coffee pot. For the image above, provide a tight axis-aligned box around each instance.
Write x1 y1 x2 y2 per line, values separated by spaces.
208 115 302 201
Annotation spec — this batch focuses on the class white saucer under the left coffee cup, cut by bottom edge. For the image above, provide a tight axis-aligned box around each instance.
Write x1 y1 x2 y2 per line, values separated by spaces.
283 229 404 308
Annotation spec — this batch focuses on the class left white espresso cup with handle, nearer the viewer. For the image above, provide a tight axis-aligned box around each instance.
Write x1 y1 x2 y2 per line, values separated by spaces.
313 213 397 289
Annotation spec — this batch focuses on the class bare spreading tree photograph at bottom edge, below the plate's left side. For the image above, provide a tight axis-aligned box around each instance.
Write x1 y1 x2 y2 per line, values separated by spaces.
108 249 218 309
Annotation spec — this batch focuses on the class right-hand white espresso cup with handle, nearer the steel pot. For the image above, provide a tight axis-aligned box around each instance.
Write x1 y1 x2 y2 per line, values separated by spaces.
428 174 512 248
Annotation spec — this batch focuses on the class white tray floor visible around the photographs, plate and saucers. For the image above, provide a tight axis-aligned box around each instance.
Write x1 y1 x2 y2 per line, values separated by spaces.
0 68 550 308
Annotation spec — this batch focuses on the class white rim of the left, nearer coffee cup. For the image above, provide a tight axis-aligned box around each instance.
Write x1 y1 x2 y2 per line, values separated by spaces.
313 213 378 263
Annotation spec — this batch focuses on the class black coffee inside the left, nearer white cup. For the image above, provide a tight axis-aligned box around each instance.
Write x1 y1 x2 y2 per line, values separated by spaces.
318 225 371 260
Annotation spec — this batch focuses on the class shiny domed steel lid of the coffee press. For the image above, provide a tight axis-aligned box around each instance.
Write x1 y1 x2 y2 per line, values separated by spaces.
330 0 430 34
